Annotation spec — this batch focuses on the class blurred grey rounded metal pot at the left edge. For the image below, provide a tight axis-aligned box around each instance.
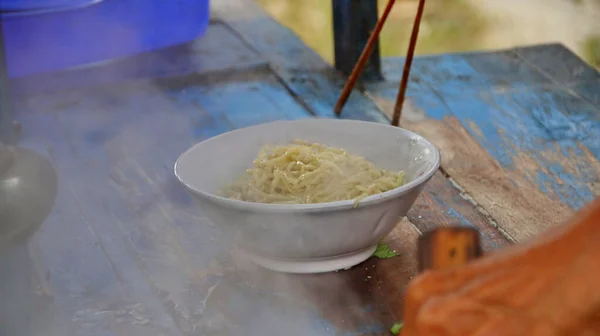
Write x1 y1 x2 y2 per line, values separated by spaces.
0 143 58 335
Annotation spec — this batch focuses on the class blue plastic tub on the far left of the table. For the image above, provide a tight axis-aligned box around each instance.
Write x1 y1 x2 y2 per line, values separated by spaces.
2 0 209 78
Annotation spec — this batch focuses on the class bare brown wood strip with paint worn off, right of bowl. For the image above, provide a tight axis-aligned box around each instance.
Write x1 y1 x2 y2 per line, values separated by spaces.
370 93 573 242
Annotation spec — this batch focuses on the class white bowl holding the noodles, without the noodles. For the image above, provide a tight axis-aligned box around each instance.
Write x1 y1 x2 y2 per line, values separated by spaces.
175 119 440 273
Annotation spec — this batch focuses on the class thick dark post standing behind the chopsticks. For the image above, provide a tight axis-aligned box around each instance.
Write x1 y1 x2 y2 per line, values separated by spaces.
332 0 383 81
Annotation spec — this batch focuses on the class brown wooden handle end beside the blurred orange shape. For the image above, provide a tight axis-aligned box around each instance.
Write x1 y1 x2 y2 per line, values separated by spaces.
417 227 482 272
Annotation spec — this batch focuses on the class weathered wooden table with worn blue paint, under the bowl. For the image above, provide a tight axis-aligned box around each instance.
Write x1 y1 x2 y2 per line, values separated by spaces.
0 0 600 336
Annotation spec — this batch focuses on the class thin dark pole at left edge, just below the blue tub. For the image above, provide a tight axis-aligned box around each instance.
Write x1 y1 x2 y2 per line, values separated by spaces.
0 18 16 144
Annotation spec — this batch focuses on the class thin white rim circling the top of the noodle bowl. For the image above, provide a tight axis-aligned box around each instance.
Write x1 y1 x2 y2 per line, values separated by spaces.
173 118 441 213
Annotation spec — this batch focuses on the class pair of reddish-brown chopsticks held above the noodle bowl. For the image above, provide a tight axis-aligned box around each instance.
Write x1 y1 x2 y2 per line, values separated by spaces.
334 0 425 126
